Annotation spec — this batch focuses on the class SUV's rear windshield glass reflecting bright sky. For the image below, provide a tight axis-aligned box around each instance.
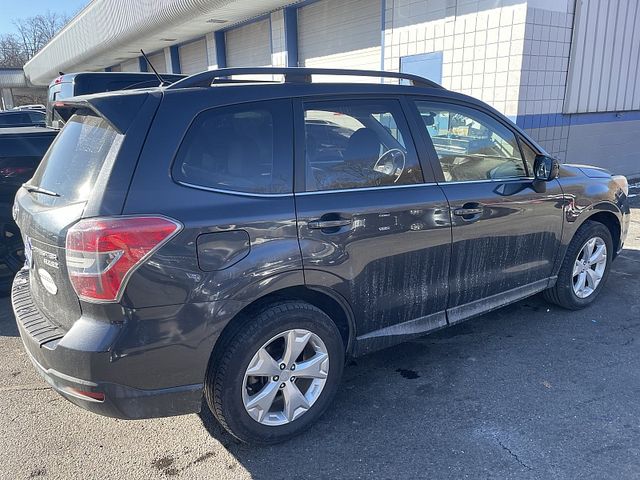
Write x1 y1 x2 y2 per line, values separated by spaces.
29 111 123 203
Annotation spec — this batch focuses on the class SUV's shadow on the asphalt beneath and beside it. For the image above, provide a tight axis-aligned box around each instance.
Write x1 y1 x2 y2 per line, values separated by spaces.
194 246 640 479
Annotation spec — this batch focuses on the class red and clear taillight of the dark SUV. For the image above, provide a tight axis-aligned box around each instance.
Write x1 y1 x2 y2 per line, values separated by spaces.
66 217 181 302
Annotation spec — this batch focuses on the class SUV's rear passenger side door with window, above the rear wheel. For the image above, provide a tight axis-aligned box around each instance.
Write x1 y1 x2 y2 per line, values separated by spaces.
296 97 451 353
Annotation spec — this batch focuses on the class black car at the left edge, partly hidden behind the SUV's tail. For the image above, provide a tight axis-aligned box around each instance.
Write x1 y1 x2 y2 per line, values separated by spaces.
0 127 58 294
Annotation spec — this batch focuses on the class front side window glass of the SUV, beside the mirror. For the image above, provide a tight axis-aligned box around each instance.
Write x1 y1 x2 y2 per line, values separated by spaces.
416 101 527 182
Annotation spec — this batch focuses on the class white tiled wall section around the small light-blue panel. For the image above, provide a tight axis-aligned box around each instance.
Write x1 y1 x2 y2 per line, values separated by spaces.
384 0 527 119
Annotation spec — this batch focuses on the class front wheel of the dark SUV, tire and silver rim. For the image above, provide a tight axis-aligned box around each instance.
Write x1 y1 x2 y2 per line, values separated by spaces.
544 221 613 310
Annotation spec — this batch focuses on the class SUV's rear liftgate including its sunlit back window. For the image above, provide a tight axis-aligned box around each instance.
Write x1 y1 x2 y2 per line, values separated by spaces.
16 110 123 328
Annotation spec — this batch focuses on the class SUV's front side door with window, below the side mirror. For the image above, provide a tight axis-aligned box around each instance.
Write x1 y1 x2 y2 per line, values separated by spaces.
416 100 563 323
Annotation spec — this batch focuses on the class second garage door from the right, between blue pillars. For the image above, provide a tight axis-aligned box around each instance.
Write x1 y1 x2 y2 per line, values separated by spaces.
225 19 271 67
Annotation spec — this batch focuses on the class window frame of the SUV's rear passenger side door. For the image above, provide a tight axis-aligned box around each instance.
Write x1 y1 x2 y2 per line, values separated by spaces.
293 93 436 195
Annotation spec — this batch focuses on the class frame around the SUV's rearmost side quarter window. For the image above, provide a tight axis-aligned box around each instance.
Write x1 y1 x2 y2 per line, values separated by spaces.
169 98 296 198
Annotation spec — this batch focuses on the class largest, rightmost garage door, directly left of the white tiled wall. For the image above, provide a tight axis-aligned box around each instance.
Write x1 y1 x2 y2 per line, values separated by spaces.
298 0 381 74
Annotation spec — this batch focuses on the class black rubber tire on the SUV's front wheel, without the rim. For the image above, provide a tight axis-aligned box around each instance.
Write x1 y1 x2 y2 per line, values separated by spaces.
544 220 614 310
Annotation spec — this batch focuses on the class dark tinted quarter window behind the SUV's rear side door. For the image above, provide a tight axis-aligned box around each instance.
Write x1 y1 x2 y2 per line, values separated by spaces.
173 100 293 194
